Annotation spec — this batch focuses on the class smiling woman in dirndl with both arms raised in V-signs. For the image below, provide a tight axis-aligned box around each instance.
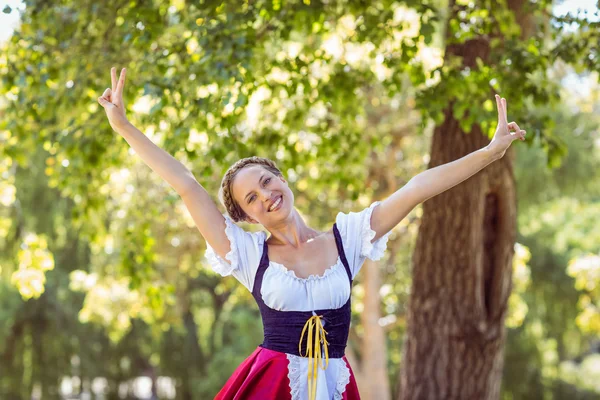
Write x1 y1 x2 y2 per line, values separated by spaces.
98 68 525 400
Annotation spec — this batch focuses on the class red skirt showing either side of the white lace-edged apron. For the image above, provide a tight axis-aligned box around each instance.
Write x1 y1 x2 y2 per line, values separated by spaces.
215 347 360 400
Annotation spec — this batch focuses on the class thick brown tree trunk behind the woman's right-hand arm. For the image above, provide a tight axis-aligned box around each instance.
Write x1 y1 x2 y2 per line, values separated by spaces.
399 0 524 400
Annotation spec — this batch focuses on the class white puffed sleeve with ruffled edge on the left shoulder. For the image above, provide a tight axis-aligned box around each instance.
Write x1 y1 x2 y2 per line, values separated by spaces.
205 214 266 291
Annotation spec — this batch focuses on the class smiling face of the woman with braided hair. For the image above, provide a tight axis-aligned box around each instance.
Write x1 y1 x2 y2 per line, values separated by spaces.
231 165 294 226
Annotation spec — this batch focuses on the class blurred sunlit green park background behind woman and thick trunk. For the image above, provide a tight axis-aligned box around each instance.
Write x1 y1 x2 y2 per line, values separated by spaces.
0 0 600 400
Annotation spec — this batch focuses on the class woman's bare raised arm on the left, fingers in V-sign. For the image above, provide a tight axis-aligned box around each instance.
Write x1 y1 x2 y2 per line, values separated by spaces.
98 68 230 258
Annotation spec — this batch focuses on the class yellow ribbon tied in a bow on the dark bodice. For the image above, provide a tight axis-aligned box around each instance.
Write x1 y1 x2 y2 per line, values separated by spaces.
298 315 329 400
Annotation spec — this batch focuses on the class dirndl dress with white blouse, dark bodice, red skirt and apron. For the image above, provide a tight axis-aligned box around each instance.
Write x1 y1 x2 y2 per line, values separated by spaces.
206 202 390 400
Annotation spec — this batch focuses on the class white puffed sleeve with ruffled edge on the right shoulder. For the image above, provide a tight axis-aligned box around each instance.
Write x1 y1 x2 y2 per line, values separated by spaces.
335 201 391 278
